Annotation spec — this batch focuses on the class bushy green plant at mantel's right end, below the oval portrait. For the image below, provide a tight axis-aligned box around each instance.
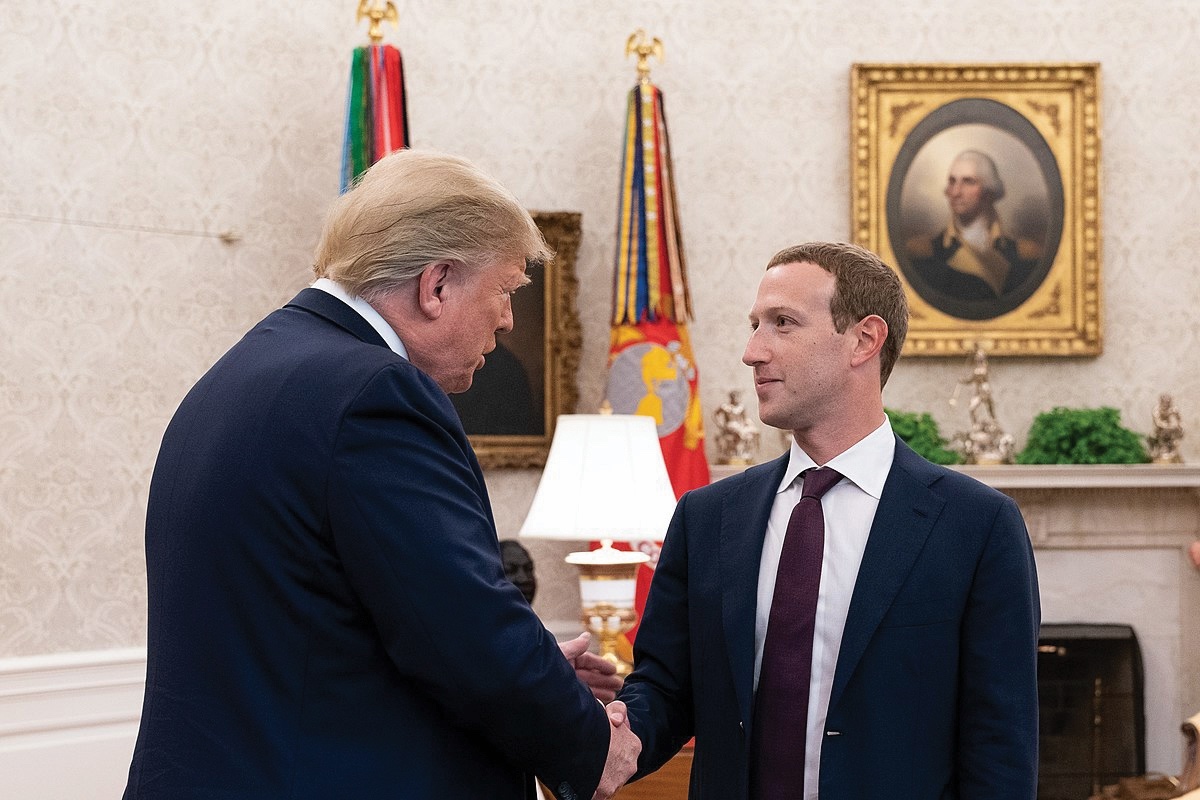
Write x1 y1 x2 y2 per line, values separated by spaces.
1016 407 1150 464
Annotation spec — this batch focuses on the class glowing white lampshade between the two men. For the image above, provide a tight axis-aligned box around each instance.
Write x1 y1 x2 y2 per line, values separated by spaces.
518 414 676 541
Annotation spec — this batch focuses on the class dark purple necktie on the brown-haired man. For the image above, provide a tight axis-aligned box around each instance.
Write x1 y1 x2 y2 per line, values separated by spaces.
750 467 841 800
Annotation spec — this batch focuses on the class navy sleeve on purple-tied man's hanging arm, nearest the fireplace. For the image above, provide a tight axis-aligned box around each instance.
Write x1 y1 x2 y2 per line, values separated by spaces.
956 498 1040 800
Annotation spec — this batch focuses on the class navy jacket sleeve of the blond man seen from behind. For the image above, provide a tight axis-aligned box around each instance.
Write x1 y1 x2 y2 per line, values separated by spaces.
328 365 608 798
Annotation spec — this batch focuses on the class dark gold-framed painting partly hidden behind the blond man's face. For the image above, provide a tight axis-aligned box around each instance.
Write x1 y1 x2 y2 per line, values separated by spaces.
450 211 583 469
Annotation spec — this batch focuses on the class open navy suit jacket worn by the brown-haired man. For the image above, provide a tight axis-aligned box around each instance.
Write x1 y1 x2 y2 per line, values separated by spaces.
620 439 1039 800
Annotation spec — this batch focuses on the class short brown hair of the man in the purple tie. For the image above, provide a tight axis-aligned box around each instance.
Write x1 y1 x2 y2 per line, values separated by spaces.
767 242 908 386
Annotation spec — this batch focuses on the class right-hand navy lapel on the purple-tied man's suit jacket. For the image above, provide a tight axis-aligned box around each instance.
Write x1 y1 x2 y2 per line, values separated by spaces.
829 439 946 709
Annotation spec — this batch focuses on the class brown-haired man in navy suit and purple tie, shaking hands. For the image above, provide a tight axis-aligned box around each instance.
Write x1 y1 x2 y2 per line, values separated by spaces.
619 243 1039 800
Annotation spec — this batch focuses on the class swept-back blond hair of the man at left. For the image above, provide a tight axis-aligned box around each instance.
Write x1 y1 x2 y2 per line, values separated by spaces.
313 150 551 300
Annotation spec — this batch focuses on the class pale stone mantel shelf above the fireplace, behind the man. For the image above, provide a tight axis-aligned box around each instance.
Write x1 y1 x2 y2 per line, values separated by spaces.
712 464 1200 489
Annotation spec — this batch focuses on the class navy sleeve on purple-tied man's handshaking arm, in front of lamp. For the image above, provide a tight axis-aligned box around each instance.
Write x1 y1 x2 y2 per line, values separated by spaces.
617 494 695 777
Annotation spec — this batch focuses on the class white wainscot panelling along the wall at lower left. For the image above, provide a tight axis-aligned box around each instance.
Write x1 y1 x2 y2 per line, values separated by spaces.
0 648 146 800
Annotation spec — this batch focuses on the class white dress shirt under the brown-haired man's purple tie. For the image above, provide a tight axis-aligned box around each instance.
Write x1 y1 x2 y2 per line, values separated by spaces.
754 417 895 800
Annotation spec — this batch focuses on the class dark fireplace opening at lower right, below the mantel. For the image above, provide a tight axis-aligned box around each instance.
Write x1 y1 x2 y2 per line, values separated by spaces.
1038 624 1146 800
